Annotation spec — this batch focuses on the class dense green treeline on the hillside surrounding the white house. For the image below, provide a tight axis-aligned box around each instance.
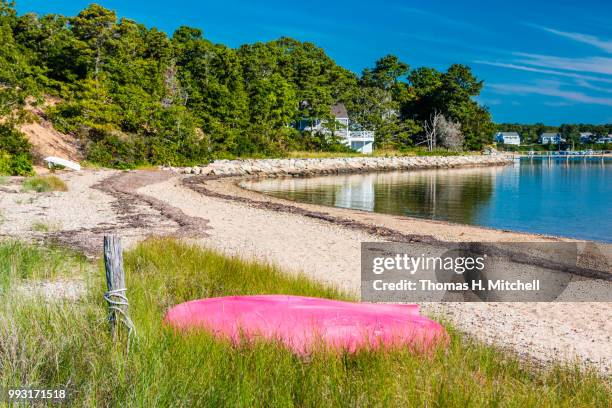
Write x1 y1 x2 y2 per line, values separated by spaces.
0 0 494 172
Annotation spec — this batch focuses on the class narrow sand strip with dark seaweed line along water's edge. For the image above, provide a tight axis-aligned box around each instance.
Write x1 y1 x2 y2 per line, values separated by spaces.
181 172 612 281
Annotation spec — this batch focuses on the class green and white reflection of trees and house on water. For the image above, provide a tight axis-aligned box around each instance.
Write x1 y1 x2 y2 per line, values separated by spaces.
245 167 503 223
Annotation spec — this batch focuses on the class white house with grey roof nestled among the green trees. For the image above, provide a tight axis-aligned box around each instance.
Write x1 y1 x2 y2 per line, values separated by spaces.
298 103 374 154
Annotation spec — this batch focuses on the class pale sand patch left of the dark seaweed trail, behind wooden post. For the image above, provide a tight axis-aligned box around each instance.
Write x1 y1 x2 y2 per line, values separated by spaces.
0 170 179 257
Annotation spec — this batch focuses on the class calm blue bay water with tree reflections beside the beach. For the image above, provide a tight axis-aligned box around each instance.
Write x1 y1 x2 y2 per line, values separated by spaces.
245 158 612 242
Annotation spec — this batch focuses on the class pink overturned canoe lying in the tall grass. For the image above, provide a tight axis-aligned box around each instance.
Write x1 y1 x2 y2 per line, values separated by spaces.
164 295 448 354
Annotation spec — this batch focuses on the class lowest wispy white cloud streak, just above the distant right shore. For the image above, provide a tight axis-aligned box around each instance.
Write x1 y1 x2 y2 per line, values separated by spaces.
489 81 612 106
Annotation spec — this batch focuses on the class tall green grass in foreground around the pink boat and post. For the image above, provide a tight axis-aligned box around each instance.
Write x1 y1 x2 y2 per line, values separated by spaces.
0 240 611 407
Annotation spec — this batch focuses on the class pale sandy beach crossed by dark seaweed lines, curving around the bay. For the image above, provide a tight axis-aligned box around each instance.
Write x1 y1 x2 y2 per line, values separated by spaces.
0 164 612 374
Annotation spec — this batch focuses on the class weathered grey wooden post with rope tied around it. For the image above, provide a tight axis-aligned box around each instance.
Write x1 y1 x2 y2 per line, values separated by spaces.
104 235 129 336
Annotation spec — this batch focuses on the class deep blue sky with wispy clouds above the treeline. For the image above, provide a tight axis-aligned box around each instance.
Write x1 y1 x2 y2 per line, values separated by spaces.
17 0 612 125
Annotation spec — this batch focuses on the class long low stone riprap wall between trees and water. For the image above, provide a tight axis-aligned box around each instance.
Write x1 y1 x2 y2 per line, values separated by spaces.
162 155 513 177
